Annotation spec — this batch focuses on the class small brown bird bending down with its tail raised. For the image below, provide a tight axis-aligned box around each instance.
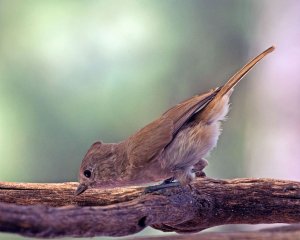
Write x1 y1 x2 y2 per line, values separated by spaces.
75 46 274 195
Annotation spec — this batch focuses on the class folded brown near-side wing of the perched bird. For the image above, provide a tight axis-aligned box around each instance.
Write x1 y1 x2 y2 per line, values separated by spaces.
127 90 218 166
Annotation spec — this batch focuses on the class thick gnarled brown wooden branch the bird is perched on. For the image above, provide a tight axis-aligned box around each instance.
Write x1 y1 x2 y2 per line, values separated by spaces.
0 178 300 238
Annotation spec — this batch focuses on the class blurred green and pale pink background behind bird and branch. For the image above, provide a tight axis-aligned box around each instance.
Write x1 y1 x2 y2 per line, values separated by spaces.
0 0 300 240
